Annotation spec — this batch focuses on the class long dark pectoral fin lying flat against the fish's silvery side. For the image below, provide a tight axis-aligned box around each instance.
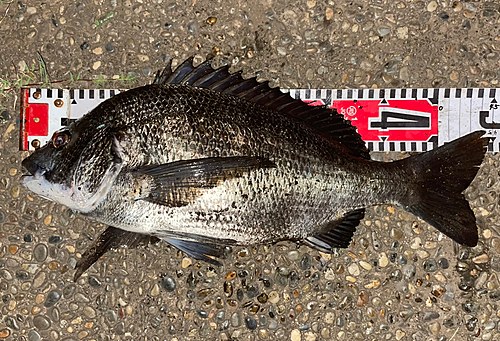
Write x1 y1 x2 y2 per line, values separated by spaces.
137 156 275 207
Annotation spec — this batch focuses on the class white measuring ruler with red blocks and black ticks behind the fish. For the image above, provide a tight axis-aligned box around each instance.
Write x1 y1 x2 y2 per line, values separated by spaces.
19 88 500 152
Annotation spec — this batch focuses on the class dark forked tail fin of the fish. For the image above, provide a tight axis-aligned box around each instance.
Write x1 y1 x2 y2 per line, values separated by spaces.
401 131 488 246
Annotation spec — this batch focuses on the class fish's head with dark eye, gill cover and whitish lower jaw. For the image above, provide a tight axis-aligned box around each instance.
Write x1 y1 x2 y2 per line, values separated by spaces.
21 120 122 213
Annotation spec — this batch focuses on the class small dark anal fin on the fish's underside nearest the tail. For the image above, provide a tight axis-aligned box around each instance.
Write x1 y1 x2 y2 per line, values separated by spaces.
303 208 365 253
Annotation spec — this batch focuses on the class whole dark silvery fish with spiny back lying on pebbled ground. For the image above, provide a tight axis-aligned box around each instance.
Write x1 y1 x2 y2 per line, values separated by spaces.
21 58 488 280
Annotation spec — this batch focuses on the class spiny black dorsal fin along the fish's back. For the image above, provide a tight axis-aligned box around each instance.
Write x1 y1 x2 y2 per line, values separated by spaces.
153 58 370 159
